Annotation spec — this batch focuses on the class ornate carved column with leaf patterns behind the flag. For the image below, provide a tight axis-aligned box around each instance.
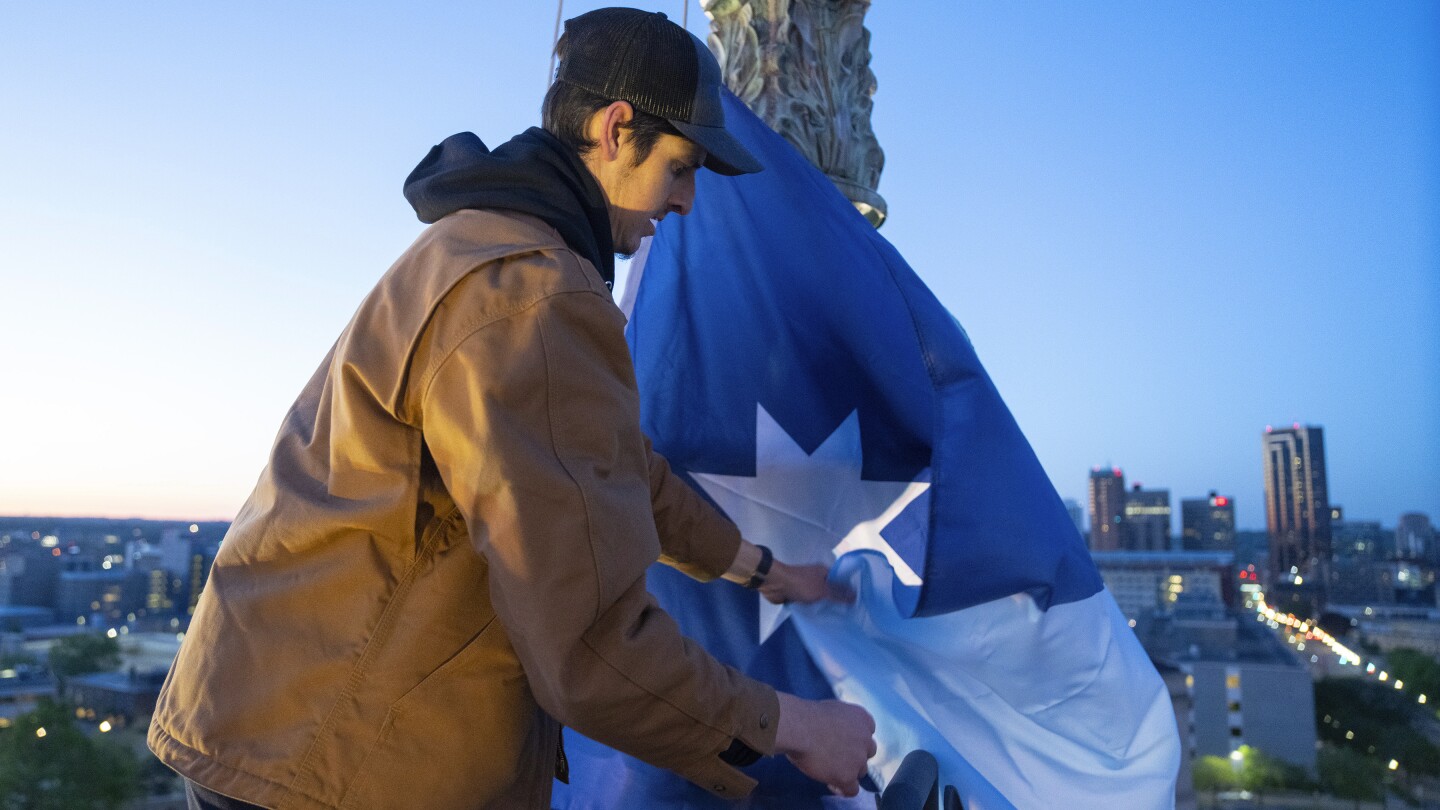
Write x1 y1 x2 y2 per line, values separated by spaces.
700 0 886 228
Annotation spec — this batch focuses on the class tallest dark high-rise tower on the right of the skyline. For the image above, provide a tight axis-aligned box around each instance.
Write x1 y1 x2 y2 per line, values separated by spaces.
1261 424 1331 590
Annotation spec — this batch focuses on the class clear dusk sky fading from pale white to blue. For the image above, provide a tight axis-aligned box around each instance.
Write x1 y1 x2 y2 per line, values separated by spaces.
0 0 1440 528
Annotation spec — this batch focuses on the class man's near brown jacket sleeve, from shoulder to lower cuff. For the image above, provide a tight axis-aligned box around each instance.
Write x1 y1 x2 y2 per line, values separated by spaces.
420 281 779 797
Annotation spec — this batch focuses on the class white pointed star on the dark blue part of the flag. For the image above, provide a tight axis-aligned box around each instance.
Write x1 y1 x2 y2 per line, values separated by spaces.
691 405 930 641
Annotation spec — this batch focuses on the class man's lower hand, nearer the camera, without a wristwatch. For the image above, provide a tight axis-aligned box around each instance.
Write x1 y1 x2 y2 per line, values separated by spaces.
775 692 876 796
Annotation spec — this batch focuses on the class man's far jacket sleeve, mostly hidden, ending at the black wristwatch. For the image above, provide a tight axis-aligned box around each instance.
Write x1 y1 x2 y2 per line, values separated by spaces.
645 438 740 582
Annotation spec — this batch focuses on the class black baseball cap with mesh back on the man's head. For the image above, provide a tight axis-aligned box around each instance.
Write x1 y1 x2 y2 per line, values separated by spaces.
556 9 763 174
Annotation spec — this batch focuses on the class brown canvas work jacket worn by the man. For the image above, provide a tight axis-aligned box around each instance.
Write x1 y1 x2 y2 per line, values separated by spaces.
150 210 779 809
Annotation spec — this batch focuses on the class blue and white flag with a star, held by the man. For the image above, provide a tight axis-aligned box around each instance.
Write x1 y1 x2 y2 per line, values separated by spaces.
556 94 1179 810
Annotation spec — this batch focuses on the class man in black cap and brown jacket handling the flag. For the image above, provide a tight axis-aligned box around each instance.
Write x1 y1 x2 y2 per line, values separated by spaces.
150 9 874 809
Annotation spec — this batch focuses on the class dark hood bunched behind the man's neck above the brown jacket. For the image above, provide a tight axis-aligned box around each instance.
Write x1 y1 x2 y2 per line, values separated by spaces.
405 127 615 287
